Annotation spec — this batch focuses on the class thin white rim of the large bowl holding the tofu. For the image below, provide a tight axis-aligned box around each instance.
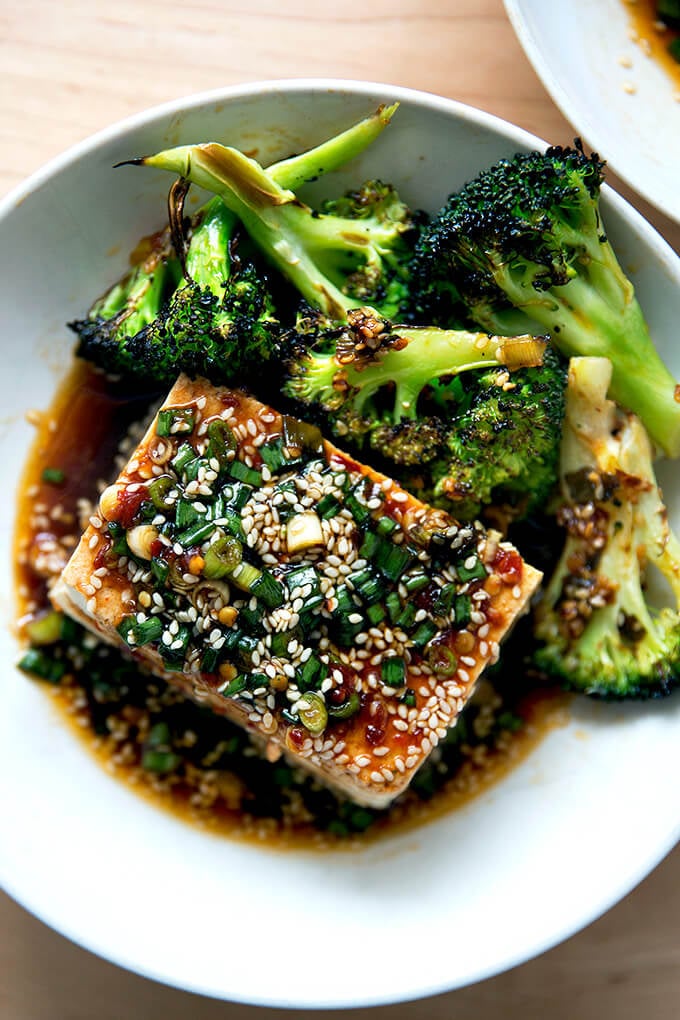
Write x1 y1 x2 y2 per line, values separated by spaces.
0 75 680 1010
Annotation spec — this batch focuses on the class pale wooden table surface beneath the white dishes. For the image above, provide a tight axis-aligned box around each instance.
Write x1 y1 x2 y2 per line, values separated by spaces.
0 0 680 1020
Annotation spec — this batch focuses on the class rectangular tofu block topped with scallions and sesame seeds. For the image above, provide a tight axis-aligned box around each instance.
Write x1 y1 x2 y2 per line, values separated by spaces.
52 376 540 807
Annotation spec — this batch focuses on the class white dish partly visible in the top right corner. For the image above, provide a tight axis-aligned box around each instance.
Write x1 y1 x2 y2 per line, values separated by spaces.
505 0 680 221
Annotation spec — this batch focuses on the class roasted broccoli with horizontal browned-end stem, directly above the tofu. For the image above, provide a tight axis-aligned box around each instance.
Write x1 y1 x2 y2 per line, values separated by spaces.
282 310 566 519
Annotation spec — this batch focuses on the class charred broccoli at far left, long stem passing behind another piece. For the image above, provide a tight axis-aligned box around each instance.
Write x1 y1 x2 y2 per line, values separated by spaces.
71 104 398 380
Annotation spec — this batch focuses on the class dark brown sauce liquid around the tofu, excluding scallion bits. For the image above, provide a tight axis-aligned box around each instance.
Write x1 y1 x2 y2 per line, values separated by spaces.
15 362 567 849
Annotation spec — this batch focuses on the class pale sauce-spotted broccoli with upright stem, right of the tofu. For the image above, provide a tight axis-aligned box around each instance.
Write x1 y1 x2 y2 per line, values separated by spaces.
535 358 680 699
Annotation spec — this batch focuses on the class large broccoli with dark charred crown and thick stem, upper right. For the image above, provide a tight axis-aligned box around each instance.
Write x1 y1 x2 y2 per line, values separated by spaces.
413 141 680 457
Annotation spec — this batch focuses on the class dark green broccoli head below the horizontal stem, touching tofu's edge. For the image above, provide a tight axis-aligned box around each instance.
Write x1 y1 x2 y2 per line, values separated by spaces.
425 347 567 519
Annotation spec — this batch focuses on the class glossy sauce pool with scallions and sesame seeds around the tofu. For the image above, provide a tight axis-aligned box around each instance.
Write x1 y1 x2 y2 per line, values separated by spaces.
16 363 565 846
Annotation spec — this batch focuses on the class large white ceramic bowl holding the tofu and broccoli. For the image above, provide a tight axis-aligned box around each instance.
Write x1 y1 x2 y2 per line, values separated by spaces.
0 81 680 1007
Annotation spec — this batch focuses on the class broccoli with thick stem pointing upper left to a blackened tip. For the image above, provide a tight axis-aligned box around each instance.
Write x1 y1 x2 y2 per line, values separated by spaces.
134 121 416 321
